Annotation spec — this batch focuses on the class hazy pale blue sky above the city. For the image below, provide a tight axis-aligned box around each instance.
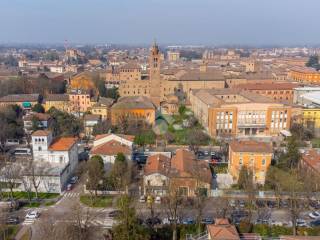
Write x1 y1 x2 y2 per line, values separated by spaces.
0 0 320 45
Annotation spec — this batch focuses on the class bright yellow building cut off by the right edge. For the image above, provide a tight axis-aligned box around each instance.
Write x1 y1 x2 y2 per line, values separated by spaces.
303 108 320 136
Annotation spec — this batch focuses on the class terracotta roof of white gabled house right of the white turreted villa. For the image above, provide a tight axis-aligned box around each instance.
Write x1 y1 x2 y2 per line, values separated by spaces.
90 140 131 156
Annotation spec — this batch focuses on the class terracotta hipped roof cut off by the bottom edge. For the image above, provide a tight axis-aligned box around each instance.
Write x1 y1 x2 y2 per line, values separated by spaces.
207 224 240 240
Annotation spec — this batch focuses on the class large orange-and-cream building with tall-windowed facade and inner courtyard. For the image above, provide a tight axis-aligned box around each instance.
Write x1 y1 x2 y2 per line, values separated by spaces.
190 88 293 137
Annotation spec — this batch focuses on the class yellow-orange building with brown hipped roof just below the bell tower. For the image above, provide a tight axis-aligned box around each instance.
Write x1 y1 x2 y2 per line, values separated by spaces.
111 96 156 125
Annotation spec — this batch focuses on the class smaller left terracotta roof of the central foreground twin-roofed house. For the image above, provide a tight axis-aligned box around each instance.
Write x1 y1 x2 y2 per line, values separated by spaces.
144 154 170 175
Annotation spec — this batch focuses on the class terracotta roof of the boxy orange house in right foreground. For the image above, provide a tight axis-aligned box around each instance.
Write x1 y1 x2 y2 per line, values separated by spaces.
229 141 273 153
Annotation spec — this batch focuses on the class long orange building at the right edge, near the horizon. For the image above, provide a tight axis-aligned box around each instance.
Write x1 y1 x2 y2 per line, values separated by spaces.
289 67 320 84
